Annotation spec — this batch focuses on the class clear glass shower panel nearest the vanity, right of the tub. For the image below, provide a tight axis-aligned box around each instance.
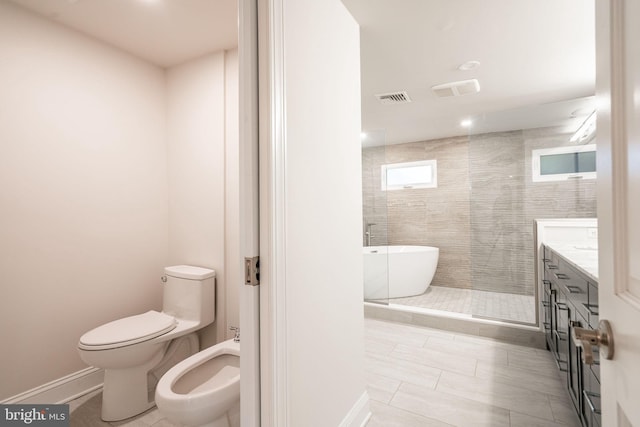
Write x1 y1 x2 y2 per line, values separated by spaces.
469 111 536 324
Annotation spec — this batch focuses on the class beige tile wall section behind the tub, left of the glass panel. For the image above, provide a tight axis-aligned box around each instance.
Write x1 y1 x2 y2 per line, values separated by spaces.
363 136 471 288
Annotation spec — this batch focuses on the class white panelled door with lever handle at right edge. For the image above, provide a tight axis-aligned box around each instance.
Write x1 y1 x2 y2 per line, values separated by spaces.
596 0 640 427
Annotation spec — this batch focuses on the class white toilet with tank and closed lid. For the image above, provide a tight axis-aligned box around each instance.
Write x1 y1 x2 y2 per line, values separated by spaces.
78 265 216 421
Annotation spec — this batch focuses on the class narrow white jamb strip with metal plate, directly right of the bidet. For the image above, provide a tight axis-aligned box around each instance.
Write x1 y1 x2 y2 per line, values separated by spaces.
238 0 260 427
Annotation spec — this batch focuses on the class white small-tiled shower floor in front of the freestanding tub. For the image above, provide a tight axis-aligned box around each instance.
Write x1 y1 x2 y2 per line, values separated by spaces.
389 286 536 323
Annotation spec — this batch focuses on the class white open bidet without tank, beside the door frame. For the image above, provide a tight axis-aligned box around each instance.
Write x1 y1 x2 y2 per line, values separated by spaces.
155 339 240 427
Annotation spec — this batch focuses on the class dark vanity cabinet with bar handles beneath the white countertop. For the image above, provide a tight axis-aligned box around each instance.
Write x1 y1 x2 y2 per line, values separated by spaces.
541 246 600 427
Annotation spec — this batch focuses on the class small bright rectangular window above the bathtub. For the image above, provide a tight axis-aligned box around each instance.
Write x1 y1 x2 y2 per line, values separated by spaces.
381 160 438 191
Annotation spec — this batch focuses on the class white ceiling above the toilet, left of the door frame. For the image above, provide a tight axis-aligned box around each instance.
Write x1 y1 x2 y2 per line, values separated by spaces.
11 0 238 67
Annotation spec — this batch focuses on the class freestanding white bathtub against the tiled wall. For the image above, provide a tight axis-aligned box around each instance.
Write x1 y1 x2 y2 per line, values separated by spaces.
362 246 440 300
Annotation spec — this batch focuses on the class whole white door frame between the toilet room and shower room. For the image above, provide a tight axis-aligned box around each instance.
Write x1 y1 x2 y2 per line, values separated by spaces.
238 0 288 427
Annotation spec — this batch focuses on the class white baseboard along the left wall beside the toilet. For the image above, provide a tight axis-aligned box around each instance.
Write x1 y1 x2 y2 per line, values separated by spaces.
0 368 104 405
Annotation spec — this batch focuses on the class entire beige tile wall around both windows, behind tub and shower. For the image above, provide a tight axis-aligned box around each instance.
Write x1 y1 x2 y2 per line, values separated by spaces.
362 128 596 295
